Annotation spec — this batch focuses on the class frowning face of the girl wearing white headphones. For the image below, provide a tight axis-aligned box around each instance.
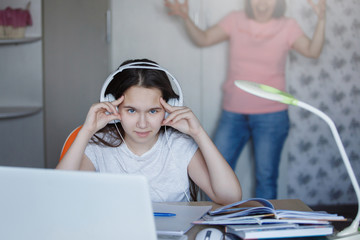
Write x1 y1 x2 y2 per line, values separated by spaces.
119 86 165 154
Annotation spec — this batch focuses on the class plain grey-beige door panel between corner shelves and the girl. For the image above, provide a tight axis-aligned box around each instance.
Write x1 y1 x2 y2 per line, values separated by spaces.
44 0 108 168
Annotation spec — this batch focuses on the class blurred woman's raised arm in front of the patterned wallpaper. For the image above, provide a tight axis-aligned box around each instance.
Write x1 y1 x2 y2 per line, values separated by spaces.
292 0 326 58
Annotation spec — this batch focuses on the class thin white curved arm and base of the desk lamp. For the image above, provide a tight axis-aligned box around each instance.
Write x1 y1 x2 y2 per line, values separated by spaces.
296 101 360 236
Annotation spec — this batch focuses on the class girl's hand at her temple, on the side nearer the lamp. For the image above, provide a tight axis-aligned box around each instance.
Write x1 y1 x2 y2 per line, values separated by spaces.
160 98 202 138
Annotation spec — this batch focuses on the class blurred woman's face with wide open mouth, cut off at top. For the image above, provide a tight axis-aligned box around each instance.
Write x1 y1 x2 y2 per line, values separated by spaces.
250 0 277 22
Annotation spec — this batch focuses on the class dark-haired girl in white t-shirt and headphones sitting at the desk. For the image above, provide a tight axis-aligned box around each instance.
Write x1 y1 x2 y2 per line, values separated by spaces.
57 59 242 204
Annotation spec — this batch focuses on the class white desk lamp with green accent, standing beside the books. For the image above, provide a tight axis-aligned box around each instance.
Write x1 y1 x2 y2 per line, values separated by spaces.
235 80 360 240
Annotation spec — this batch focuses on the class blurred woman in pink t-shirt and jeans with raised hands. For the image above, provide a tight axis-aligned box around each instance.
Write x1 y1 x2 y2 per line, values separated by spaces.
165 0 326 199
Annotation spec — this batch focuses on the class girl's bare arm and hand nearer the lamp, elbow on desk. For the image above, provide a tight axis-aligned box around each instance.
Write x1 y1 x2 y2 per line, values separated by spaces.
160 99 242 204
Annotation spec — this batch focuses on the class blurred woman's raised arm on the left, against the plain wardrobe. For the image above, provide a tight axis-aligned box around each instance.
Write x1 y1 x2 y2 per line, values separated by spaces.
165 0 228 47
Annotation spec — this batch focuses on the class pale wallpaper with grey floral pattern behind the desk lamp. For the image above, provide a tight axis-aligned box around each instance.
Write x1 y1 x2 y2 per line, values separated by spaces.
285 0 360 205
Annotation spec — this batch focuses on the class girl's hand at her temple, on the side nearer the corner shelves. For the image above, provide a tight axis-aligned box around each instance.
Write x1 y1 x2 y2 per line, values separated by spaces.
83 96 124 135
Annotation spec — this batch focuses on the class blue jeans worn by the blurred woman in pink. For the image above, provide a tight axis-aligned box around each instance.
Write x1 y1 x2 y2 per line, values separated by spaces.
214 110 289 199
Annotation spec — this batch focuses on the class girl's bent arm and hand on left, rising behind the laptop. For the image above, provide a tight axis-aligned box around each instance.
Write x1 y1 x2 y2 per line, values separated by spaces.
56 97 124 171
